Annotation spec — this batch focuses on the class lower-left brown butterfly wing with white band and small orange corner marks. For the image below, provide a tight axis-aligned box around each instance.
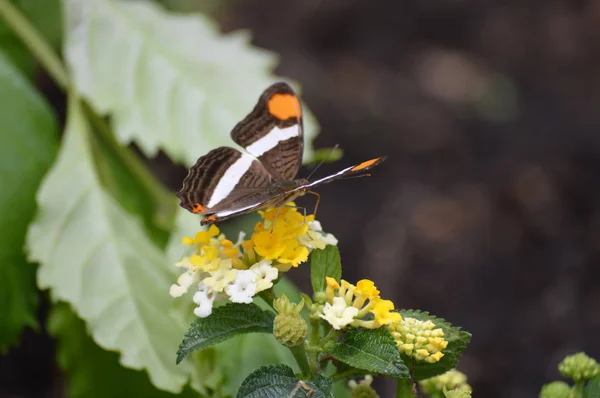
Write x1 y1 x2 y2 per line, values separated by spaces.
177 147 273 224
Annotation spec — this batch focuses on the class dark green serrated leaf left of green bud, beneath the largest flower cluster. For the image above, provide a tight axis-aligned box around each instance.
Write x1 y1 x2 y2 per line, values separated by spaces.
177 303 275 363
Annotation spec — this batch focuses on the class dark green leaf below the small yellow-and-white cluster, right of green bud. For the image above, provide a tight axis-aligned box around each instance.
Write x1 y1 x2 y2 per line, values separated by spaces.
329 328 408 378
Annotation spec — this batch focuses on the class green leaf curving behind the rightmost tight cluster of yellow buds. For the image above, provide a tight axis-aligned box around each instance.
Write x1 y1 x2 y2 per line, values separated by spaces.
399 310 471 381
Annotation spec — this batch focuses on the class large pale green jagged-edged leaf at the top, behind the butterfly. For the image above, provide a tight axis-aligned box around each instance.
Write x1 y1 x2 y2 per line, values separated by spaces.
65 0 316 165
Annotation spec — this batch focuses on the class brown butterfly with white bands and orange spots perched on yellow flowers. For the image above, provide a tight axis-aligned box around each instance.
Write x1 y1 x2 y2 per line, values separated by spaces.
177 82 385 225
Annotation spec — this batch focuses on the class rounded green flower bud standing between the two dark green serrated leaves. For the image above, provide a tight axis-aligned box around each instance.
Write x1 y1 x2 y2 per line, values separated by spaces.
273 296 308 347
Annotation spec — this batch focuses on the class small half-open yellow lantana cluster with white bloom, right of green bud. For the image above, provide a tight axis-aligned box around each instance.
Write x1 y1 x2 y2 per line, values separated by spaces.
318 277 402 330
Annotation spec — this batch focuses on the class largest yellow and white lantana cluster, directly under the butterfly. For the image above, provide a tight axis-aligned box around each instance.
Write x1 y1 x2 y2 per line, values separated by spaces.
169 203 337 318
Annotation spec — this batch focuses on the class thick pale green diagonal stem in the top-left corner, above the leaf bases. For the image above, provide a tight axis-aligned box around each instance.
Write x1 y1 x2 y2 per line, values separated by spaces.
0 0 70 91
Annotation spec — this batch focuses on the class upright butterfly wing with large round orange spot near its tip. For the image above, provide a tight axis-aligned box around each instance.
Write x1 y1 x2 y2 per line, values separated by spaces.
231 82 304 181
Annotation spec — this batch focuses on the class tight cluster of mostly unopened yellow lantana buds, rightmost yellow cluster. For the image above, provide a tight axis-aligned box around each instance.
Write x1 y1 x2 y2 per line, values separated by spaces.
389 317 448 363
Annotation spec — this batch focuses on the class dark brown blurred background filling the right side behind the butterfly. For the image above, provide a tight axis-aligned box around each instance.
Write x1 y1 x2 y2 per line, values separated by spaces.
3 0 600 398
